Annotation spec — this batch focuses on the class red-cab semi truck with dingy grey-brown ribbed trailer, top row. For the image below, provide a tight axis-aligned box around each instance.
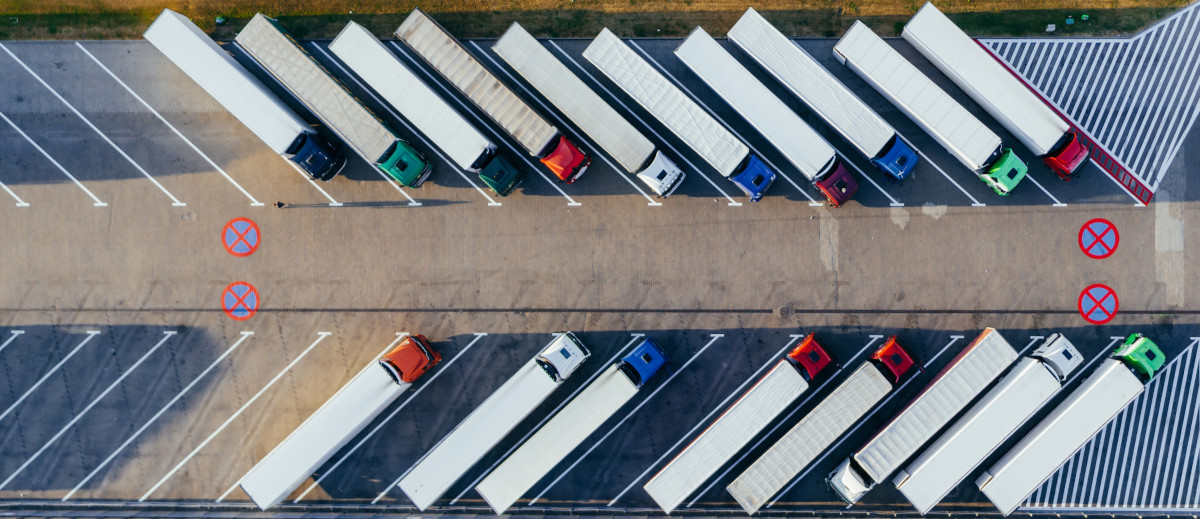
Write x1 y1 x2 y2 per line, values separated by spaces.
396 10 592 184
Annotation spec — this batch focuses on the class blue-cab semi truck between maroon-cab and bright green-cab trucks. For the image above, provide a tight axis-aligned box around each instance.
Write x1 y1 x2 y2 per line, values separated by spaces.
728 7 918 180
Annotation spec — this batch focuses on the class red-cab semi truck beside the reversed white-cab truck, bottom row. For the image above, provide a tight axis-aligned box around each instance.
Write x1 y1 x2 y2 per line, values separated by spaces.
727 336 914 515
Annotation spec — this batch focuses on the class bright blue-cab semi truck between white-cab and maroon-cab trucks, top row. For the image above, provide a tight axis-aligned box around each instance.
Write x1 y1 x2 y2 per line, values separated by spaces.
583 29 775 202
